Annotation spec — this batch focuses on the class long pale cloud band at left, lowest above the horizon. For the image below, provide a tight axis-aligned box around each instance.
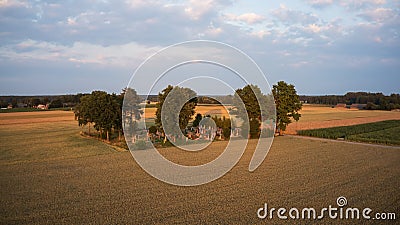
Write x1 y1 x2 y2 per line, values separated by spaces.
0 39 161 67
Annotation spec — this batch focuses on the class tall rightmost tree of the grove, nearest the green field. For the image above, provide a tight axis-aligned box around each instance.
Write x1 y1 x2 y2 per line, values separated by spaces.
272 81 302 135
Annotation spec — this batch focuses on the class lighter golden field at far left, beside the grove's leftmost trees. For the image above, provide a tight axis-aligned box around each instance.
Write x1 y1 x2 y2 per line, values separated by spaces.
0 111 113 164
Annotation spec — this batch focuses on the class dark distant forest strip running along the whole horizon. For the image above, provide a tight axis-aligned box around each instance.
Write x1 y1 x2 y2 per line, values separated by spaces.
0 92 400 110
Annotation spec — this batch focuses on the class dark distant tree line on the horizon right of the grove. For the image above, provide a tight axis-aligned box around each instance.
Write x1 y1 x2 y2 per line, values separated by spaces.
300 92 400 110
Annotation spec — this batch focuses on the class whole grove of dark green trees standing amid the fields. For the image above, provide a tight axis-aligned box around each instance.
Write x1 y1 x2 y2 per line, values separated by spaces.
75 81 301 145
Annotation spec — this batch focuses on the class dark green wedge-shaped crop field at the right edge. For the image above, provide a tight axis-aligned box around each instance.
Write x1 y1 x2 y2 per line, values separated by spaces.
298 120 400 145
